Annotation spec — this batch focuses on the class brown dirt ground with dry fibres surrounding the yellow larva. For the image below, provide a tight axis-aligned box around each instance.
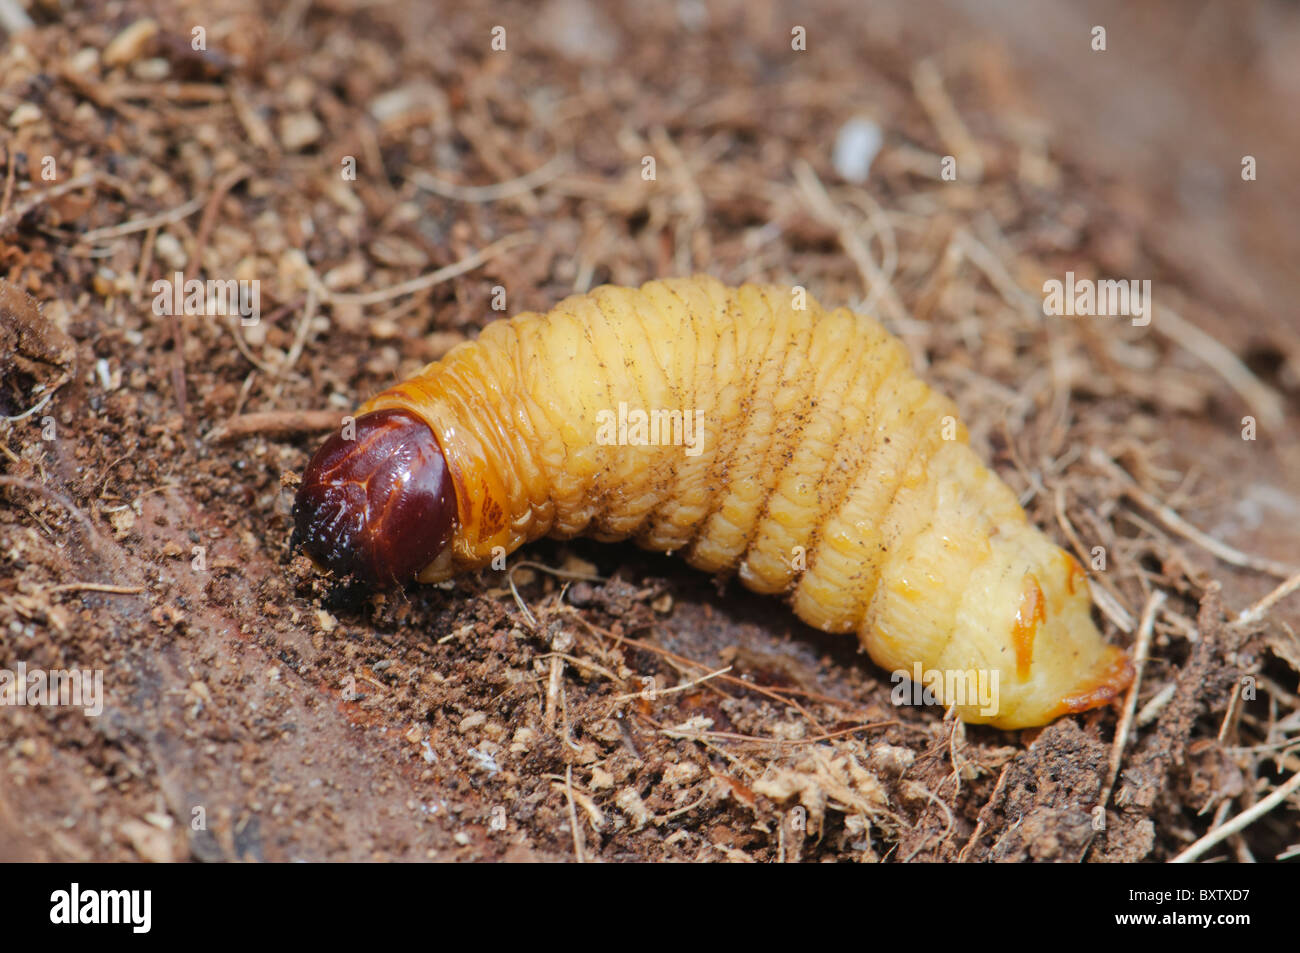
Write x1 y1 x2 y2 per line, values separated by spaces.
0 0 1300 861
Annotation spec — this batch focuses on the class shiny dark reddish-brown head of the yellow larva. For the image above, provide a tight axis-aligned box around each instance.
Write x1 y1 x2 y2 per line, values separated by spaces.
294 410 456 585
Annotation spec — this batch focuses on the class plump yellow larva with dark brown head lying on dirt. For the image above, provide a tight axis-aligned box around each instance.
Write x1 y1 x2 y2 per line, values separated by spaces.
294 277 1132 728
